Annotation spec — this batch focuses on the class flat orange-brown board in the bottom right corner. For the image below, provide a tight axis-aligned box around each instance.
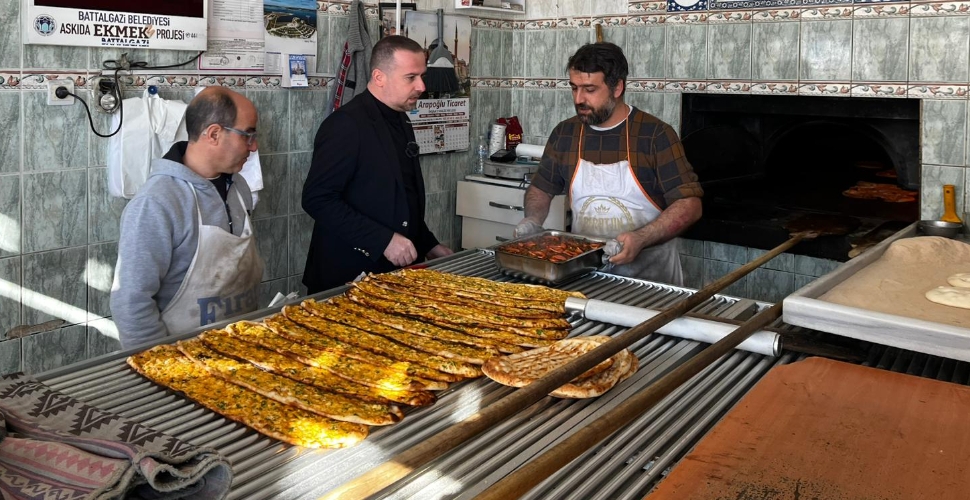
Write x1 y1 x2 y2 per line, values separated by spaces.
647 358 970 500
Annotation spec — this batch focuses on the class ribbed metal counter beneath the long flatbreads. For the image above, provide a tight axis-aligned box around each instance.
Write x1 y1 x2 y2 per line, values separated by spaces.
32 250 970 500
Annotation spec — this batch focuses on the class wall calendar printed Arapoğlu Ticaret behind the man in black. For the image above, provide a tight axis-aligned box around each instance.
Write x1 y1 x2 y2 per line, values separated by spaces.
408 97 469 154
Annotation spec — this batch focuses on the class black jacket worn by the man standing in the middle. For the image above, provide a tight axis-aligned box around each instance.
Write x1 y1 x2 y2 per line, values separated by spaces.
303 92 438 293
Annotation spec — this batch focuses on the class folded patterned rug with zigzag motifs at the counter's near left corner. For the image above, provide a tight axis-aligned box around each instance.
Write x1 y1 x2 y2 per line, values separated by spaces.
0 374 232 500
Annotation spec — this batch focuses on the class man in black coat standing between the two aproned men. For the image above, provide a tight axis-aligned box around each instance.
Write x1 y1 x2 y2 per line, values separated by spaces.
303 36 452 293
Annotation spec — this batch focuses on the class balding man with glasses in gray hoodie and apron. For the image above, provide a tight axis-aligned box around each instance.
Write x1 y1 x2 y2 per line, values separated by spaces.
111 87 263 348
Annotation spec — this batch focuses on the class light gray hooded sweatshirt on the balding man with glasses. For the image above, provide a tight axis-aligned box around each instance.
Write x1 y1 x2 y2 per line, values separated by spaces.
111 143 252 348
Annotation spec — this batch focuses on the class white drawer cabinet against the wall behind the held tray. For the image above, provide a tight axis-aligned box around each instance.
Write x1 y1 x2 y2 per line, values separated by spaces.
456 181 568 248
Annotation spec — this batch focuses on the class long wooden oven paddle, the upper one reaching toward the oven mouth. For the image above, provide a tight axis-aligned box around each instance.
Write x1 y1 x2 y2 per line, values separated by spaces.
323 217 837 500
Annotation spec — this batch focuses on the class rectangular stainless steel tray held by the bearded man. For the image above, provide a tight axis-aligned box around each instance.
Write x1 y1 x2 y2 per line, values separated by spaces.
493 230 606 285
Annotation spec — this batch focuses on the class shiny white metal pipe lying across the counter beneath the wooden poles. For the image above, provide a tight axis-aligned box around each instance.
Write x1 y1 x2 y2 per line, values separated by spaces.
566 297 781 356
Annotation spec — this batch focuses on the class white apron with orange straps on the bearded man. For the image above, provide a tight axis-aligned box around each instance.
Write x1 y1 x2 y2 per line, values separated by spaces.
569 122 684 286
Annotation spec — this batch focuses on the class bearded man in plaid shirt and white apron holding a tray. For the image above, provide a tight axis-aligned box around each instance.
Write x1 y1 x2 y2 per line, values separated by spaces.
514 43 704 286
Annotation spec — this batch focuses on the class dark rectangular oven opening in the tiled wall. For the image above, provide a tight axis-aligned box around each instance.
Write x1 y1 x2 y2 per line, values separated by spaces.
681 94 921 261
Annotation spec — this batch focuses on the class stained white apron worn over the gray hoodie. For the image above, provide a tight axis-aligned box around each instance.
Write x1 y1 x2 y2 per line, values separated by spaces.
162 184 263 335
